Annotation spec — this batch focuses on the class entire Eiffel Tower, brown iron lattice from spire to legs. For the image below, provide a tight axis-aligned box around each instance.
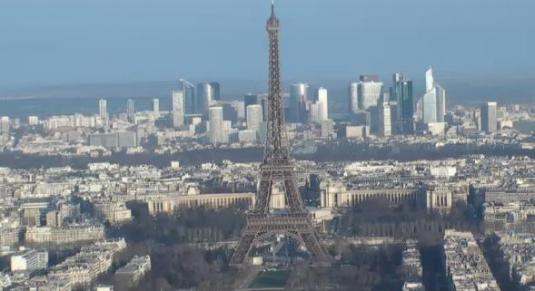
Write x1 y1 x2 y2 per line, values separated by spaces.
230 2 328 265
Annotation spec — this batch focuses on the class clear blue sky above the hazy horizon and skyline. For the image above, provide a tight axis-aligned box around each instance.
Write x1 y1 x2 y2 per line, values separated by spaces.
0 0 535 87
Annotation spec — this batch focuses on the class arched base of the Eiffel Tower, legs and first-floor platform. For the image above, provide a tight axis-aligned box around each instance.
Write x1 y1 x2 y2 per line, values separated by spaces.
230 213 330 266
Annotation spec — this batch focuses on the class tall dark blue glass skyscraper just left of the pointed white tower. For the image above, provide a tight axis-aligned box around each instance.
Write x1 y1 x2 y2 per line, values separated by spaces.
390 73 415 134
